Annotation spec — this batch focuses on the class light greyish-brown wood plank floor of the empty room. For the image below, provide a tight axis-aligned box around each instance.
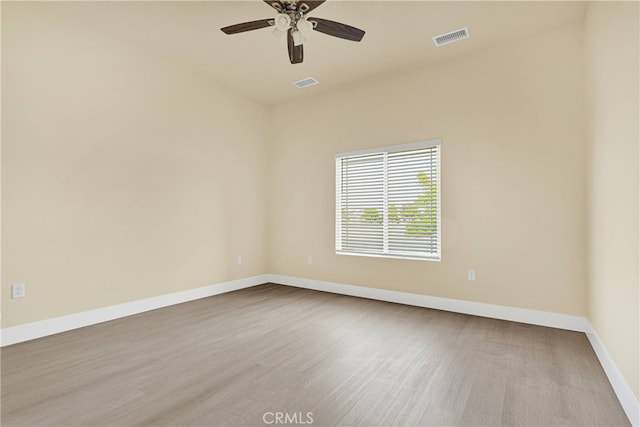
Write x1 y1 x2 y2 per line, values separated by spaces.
1 284 628 426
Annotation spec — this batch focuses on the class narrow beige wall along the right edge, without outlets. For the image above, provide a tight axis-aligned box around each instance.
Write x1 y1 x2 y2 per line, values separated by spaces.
585 2 640 397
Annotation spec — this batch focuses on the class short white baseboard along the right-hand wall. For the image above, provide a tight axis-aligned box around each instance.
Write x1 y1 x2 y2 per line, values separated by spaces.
586 323 640 427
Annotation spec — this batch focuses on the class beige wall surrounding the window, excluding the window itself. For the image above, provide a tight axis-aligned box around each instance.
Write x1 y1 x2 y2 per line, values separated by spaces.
269 25 587 316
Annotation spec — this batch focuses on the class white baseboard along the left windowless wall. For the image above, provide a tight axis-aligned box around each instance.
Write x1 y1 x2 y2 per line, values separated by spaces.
0 275 268 347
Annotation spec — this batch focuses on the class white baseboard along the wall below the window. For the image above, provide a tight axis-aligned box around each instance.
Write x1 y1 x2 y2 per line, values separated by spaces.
267 274 589 332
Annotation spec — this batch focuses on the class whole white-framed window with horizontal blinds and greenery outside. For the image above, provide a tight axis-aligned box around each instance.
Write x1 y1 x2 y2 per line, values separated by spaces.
336 140 440 260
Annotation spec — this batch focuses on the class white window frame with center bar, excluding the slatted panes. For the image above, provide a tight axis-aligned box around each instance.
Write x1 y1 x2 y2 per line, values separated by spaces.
334 139 442 261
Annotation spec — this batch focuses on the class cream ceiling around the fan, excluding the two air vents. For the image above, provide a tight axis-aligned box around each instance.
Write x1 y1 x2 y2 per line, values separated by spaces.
21 0 585 104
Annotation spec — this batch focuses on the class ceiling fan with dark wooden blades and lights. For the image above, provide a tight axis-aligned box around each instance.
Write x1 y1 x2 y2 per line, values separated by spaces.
221 0 364 64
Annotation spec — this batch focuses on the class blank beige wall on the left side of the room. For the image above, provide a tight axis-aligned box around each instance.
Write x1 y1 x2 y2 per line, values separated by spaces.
2 2 267 327
